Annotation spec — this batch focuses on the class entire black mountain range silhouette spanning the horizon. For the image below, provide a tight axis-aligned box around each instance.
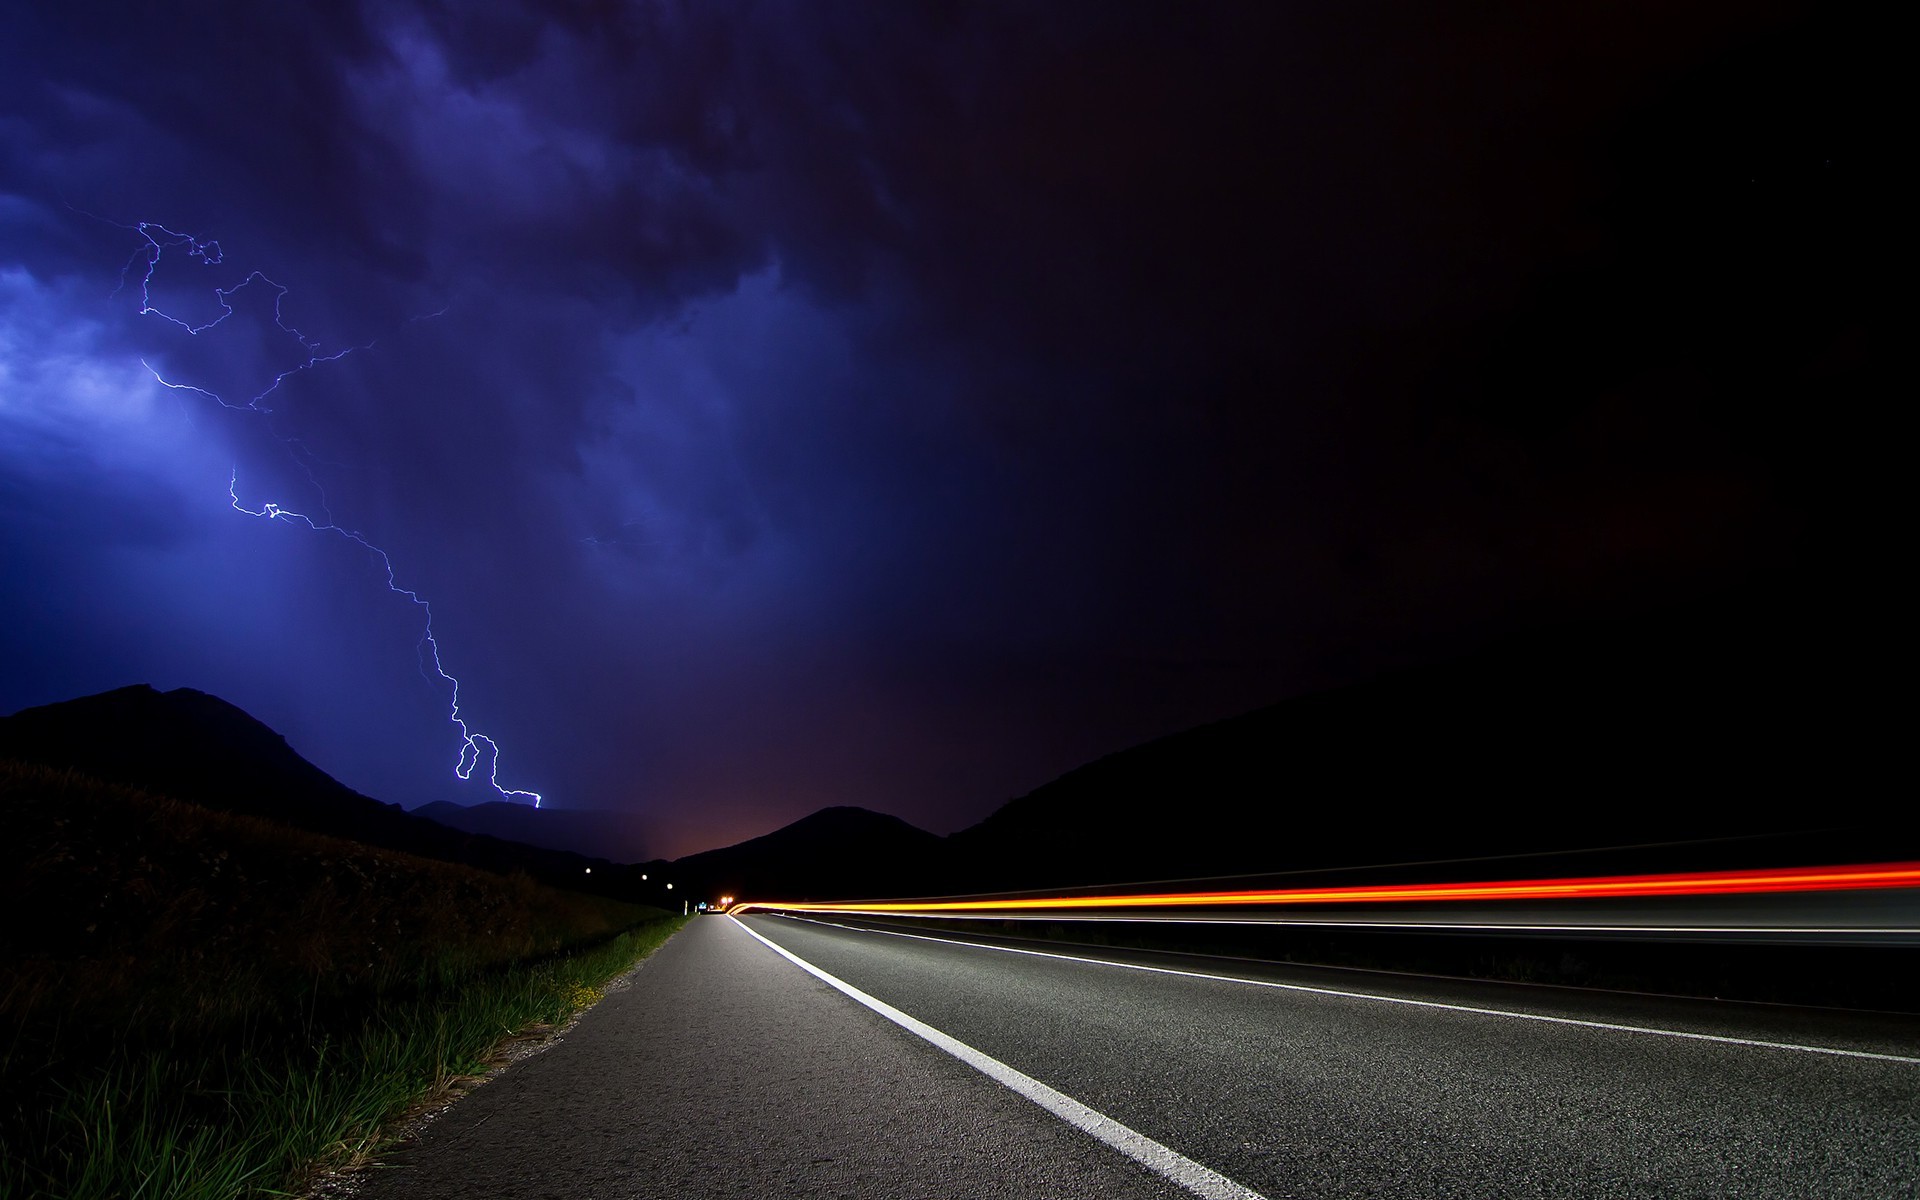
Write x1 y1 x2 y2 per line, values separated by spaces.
11 572 1920 904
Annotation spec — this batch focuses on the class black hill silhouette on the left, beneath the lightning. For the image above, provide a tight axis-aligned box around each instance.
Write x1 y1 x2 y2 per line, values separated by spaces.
0 684 632 899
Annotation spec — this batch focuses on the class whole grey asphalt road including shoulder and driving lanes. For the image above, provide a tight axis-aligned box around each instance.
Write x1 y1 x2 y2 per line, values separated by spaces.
365 916 1920 1200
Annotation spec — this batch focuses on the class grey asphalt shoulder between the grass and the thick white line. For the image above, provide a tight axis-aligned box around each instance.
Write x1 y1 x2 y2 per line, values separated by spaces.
357 918 1187 1200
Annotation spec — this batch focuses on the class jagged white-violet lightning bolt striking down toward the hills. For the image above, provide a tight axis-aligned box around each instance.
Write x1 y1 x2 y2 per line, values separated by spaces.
119 213 541 808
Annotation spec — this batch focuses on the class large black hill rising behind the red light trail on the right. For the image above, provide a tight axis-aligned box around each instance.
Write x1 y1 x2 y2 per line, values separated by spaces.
950 599 1920 889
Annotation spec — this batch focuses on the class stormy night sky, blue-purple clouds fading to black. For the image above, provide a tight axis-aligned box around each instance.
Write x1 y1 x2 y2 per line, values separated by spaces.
0 0 1889 854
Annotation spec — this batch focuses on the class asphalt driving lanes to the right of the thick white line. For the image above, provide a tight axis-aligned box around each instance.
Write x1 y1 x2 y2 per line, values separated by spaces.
747 918 1920 1198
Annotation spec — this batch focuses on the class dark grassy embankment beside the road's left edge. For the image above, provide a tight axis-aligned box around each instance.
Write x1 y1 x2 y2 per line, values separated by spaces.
0 760 682 1200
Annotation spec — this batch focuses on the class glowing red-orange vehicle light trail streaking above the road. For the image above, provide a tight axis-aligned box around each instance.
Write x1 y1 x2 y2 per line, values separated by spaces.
733 862 1920 914
